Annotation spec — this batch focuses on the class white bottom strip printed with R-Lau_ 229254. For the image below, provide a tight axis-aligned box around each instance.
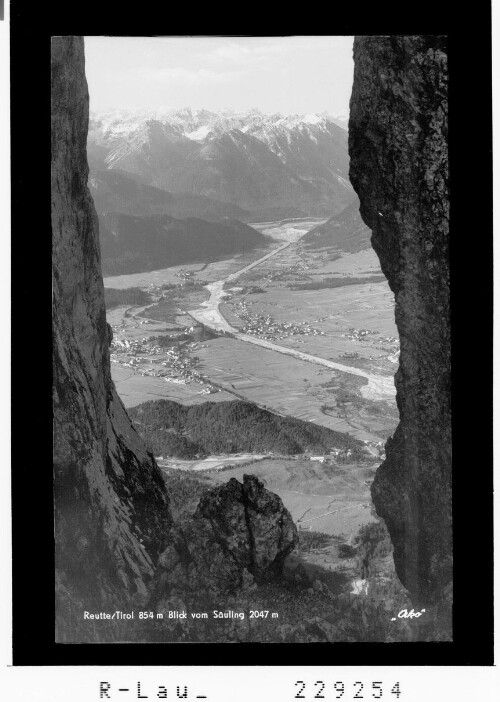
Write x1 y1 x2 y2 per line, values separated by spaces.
2 668 498 702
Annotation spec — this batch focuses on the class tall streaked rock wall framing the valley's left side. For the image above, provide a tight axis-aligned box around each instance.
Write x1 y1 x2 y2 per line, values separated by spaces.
52 37 171 641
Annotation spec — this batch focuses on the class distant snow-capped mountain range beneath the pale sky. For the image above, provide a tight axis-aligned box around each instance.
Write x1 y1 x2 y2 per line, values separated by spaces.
88 108 354 216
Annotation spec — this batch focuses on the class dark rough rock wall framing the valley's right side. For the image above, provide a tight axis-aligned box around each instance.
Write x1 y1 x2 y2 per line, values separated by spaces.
349 36 452 604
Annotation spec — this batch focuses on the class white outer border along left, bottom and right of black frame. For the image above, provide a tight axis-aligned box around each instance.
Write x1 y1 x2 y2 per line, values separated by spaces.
0 16 500 702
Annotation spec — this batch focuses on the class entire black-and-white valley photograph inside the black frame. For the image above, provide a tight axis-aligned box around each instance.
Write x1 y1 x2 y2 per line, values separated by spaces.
51 35 453 644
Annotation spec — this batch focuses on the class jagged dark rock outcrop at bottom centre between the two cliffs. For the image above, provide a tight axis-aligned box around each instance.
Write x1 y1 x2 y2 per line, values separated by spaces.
152 475 298 598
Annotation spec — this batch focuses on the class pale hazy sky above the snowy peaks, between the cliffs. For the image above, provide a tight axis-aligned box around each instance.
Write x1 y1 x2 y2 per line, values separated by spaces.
85 36 353 115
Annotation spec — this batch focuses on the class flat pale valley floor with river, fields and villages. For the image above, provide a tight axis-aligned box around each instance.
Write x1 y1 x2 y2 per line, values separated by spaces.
105 220 397 441
